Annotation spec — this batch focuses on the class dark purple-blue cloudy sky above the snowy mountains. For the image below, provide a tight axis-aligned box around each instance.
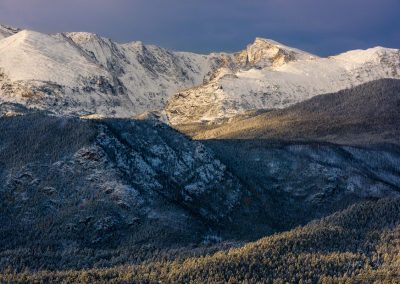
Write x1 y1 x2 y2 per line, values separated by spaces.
0 0 400 55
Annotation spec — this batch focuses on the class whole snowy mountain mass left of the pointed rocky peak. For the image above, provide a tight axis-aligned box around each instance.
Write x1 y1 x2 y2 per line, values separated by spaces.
0 30 219 117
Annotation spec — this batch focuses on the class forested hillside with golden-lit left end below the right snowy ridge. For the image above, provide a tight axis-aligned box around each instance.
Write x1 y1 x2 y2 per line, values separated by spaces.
190 79 400 144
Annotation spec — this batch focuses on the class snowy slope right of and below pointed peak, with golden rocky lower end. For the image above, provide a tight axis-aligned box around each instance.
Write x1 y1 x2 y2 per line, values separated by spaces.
166 43 400 125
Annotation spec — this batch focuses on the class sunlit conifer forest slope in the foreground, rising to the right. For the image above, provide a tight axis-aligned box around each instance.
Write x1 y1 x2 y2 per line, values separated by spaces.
0 198 400 283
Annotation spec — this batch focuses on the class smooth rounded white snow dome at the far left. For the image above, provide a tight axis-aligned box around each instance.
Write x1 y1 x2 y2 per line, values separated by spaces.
0 30 108 86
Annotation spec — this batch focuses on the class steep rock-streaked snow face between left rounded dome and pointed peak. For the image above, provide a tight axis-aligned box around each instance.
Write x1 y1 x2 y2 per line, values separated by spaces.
66 33 222 113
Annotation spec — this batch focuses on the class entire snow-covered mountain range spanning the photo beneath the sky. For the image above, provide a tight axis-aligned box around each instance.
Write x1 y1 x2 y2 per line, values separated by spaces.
0 26 400 124
